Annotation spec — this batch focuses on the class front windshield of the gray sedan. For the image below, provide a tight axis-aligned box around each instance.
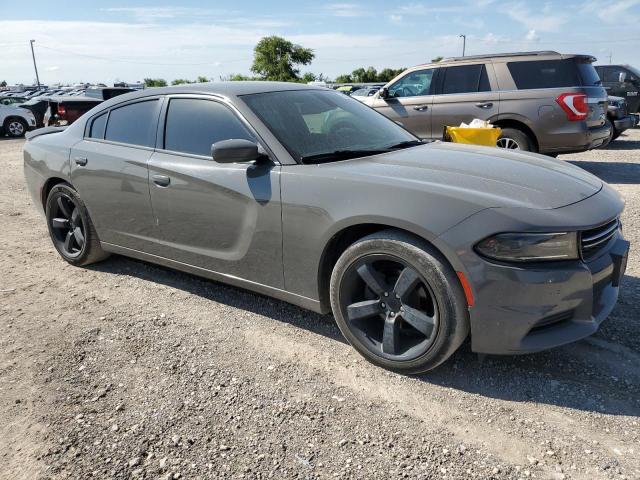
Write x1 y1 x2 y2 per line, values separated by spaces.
242 90 420 163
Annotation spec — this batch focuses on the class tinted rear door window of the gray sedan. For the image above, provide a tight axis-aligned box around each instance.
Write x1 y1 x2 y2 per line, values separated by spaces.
105 100 158 147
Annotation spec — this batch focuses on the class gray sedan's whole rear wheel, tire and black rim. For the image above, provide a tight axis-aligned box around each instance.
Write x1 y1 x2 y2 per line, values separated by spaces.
45 183 109 266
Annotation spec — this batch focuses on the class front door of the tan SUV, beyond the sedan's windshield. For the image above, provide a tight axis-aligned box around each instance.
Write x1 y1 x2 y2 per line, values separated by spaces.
371 68 436 138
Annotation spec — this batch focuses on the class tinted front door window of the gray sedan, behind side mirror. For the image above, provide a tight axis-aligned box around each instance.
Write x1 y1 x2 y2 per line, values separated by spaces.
164 98 255 156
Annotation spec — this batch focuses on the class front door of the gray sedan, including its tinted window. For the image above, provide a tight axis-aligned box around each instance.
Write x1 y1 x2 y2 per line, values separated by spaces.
149 96 284 288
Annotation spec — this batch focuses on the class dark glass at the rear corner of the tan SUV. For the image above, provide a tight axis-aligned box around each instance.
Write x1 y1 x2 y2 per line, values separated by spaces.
507 58 600 90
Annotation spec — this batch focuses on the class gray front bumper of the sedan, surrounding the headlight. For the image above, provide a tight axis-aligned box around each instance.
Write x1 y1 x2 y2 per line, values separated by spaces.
440 187 628 354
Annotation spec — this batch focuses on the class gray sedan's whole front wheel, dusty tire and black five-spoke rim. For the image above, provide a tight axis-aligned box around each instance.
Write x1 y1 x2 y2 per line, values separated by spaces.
330 230 469 374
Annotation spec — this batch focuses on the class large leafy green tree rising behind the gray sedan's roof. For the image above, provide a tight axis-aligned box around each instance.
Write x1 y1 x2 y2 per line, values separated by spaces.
251 35 315 82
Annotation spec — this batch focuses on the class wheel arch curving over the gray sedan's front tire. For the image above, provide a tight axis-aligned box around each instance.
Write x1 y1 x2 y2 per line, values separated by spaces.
317 220 461 313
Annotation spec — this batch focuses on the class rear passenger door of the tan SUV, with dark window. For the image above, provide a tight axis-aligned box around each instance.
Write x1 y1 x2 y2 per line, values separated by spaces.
431 64 500 138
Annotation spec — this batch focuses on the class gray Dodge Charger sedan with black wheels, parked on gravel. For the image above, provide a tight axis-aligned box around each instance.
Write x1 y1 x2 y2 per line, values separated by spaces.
24 82 629 373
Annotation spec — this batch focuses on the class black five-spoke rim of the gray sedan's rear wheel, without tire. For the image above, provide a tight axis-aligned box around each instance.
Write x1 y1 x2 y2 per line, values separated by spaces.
49 192 86 258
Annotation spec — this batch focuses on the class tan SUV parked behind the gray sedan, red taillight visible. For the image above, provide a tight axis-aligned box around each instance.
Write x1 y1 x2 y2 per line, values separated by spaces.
364 51 609 155
